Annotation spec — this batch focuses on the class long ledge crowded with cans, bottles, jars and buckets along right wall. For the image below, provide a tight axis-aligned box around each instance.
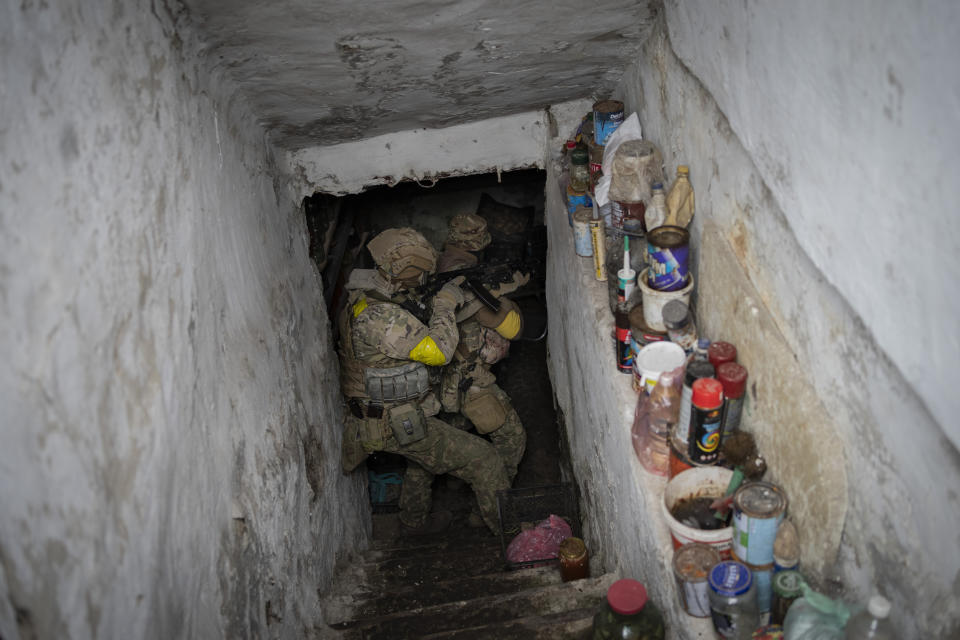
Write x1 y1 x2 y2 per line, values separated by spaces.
548 100 872 638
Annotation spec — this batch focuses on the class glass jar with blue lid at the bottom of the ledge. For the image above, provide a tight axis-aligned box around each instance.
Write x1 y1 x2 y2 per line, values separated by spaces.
709 560 760 640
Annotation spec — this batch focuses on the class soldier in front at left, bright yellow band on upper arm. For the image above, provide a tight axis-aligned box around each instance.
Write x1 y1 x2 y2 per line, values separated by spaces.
339 228 510 533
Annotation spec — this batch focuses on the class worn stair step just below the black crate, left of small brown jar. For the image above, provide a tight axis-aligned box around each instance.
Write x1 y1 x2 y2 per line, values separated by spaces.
322 566 560 624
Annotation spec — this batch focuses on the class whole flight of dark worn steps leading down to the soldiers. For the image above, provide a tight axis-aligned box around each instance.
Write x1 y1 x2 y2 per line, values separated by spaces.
321 516 615 640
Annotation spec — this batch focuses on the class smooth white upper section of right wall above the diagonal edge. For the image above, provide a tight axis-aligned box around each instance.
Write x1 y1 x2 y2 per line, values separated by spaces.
666 0 960 447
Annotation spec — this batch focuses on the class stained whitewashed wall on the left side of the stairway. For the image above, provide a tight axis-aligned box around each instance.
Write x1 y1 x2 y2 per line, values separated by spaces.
0 1 369 640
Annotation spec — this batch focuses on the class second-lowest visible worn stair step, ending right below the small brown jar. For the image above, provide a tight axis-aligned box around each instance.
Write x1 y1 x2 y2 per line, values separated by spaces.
331 574 616 640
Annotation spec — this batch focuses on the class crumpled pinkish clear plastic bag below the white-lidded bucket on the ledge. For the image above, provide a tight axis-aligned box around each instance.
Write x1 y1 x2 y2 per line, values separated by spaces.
630 366 685 476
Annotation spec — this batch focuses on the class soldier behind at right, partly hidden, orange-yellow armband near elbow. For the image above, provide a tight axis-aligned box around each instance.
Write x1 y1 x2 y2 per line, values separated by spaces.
439 214 529 490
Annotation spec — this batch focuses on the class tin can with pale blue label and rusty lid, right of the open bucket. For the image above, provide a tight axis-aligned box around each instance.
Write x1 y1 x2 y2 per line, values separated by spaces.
733 482 787 569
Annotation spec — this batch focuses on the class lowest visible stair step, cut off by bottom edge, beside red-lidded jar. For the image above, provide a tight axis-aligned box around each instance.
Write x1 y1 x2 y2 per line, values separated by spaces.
422 608 596 640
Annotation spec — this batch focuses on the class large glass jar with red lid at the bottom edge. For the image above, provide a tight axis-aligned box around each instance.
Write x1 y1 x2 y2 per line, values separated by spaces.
593 579 666 640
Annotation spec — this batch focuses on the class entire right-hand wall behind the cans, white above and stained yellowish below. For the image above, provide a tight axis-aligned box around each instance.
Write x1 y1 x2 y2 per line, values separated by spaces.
604 7 960 637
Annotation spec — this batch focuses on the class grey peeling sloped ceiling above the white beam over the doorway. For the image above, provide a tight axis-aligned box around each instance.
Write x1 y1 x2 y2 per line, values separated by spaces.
186 0 660 149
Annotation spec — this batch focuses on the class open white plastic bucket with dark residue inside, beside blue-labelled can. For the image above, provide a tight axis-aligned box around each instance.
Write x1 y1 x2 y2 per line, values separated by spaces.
660 466 733 559
